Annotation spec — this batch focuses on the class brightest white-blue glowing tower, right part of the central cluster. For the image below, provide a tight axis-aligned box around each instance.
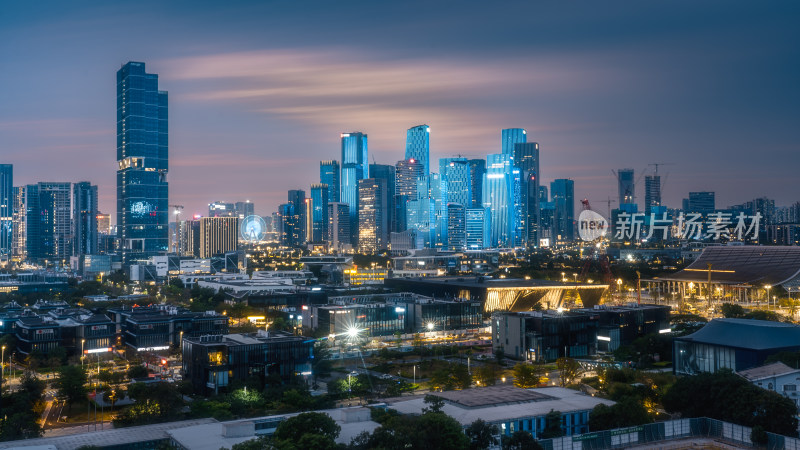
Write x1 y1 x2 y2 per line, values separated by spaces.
483 154 519 247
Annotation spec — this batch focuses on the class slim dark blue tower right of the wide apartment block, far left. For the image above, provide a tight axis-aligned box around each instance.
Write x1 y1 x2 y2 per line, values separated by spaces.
72 181 99 256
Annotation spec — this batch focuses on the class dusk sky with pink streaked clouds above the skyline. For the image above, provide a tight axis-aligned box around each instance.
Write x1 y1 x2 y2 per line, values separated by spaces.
0 0 800 221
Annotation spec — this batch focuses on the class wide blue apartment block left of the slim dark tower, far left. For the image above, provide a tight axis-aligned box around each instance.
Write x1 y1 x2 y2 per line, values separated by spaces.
25 183 72 263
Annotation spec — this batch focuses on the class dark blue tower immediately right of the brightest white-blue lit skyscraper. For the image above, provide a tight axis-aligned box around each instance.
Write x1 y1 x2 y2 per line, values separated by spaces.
514 142 539 246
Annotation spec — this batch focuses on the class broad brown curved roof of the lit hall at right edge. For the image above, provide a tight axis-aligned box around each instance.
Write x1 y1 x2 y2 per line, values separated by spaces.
660 245 800 286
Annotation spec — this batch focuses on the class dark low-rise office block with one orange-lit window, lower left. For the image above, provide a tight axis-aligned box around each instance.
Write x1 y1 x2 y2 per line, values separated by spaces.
182 331 315 394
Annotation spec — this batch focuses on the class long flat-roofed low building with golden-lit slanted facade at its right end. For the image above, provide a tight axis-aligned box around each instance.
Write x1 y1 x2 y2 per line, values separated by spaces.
384 277 608 312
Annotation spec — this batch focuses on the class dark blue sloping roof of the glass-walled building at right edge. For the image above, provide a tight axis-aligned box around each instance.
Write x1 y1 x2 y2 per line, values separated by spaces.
676 319 800 350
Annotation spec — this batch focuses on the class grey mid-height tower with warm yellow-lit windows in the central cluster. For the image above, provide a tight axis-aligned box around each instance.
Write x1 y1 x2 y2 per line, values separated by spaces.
358 178 389 253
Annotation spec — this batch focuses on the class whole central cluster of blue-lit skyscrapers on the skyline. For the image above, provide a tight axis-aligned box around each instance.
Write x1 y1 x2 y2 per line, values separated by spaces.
278 124 574 253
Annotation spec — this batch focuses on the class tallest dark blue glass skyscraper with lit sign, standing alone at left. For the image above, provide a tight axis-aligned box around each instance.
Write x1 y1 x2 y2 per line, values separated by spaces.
117 62 169 264
